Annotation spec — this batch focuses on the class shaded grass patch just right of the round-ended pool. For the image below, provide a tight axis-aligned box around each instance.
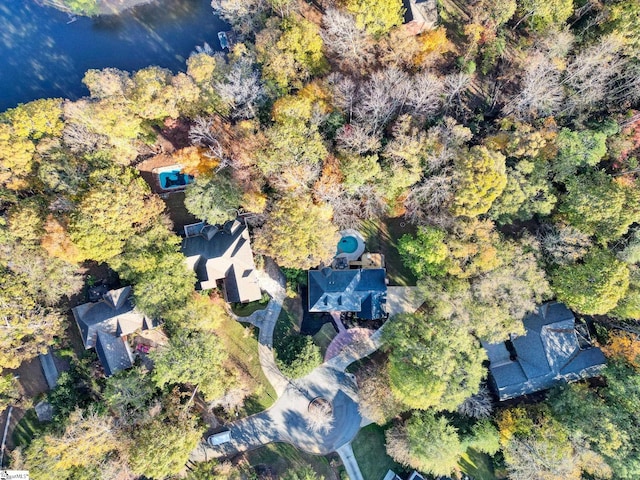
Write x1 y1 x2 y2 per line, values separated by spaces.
360 217 416 286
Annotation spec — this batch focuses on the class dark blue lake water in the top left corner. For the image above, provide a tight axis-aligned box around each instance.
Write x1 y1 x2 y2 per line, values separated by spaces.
0 0 228 111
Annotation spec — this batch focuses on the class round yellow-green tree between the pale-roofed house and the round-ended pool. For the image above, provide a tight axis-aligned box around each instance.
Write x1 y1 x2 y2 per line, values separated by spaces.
254 195 338 269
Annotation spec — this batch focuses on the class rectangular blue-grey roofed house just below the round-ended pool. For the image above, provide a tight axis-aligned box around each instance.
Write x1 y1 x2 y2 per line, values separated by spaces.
308 267 387 320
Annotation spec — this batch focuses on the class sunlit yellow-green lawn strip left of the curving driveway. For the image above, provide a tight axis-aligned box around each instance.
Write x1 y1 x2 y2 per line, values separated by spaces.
215 316 277 416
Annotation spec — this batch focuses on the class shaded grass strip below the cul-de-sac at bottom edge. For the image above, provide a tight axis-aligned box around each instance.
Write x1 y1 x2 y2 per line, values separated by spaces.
246 443 336 480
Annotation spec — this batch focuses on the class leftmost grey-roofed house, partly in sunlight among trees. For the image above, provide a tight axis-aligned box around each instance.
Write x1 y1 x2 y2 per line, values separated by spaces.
72 286 158 376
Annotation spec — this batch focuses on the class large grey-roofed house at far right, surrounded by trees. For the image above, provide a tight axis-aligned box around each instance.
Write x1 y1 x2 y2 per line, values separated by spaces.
483 303 605 400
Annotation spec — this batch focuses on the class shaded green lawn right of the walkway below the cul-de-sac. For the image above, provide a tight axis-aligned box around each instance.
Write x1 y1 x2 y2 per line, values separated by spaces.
351 424 404 480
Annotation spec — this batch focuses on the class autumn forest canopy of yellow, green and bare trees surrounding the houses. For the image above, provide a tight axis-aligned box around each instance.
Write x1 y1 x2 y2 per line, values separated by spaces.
0 0 640 480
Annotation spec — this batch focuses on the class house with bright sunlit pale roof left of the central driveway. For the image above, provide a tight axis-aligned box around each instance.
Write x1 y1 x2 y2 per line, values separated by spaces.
182 220 262 303
